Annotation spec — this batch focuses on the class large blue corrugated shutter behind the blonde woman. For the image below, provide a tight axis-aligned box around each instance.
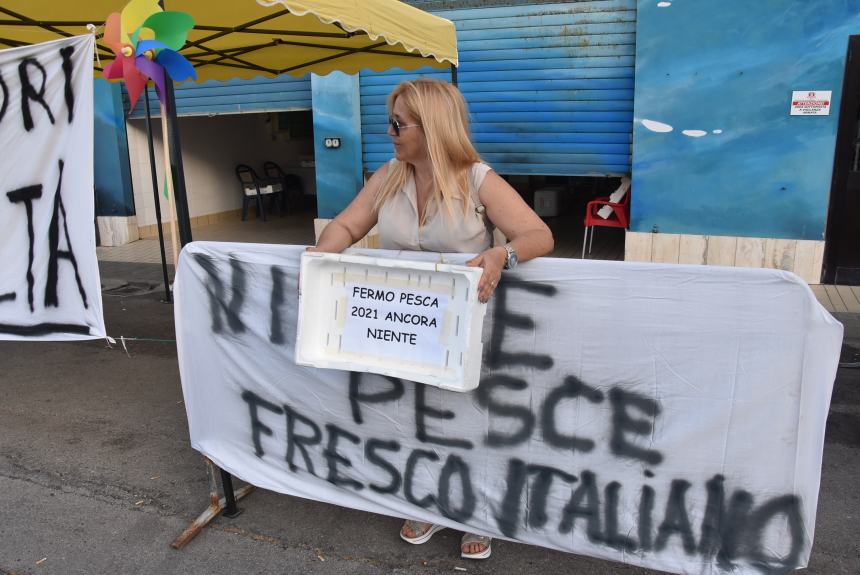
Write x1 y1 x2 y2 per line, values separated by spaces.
361 0 636 175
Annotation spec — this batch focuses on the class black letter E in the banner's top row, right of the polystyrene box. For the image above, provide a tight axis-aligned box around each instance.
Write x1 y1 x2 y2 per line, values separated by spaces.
487 279 557 369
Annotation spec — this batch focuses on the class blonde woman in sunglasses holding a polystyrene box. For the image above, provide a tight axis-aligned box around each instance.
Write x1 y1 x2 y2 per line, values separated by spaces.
310 79 553 559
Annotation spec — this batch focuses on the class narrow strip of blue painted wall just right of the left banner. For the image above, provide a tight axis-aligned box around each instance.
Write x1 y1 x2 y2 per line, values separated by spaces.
93 78 134 216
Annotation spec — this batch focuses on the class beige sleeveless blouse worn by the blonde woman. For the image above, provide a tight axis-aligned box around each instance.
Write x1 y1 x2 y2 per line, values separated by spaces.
377 160 493 253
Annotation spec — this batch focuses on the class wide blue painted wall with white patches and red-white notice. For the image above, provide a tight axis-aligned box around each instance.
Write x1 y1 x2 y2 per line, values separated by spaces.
630 0 860 240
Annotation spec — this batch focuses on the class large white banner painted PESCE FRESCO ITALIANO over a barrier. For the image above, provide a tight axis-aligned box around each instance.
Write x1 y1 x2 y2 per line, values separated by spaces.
176 243 842 575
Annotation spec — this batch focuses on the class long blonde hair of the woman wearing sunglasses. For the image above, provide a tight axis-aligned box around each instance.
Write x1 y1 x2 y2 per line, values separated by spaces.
375 78 481 224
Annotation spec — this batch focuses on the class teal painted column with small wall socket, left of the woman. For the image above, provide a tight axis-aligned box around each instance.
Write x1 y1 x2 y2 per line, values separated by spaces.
311 72 363 219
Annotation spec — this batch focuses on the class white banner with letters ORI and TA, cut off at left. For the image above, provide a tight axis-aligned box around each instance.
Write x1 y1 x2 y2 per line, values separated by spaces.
0 35 105 340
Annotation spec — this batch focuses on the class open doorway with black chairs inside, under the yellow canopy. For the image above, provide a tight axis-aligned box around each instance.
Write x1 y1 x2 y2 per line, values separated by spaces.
127 110 316 248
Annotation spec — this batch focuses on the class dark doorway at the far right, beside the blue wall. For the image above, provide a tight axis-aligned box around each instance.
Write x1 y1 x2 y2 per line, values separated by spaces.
822 36 860 285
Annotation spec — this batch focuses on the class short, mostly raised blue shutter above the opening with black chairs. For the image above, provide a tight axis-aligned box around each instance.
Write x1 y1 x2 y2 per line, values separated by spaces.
123 74 311 118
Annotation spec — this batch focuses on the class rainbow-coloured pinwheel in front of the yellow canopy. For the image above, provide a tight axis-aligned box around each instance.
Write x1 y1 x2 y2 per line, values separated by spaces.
104 0 197 108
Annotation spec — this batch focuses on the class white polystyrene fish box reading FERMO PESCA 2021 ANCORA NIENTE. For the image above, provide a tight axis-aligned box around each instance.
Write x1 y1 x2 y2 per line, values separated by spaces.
296 252 487 391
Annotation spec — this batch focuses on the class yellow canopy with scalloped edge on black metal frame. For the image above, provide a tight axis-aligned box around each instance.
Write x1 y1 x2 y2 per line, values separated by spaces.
0 0 457 81
